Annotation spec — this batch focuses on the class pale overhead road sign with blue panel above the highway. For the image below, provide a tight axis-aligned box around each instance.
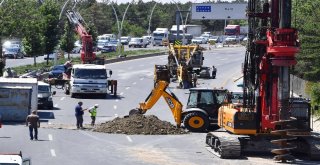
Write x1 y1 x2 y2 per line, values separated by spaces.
191 3 248 20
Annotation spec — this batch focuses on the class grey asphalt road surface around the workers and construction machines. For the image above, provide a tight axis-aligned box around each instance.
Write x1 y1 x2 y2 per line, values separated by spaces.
0 47 317 165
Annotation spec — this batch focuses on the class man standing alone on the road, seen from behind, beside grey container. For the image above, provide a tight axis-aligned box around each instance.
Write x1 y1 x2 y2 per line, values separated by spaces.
26 110 40 140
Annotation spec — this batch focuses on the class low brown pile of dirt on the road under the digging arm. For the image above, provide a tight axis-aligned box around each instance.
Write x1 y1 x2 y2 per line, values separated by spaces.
93 114 186 135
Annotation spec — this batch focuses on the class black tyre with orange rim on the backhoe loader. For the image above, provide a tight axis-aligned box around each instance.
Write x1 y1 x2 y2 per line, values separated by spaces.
183 112 209 132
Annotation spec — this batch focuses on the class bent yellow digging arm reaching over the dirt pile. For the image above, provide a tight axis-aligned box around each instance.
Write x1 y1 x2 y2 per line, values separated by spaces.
129 81 182 127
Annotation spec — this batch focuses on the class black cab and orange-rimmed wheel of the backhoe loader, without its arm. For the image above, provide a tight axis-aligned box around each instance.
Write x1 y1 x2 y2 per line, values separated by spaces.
182 88 227 132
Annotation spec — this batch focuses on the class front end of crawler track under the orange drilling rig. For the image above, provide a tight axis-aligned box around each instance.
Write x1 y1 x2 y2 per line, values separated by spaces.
206 131 241 158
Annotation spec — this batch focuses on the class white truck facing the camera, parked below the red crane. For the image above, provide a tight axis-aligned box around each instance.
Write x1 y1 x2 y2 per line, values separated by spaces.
65 64 117 97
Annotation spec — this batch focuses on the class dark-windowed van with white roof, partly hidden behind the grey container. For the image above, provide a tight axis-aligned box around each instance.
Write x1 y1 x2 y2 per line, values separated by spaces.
38 81 56 109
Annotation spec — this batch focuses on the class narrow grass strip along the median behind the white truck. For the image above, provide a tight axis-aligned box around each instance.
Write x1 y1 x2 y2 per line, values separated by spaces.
13 49 163 75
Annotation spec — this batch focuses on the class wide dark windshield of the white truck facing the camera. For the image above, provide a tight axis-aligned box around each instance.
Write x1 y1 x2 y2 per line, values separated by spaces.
74 69 107 79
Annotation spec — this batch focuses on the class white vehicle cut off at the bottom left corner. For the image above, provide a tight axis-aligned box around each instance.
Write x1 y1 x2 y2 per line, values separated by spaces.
0 152 31 165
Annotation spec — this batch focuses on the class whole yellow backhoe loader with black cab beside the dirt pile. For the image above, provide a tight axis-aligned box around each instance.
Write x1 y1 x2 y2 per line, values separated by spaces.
129 68 227 132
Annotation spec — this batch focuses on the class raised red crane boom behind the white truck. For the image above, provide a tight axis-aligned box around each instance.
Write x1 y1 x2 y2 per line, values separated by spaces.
67 10 96 64
